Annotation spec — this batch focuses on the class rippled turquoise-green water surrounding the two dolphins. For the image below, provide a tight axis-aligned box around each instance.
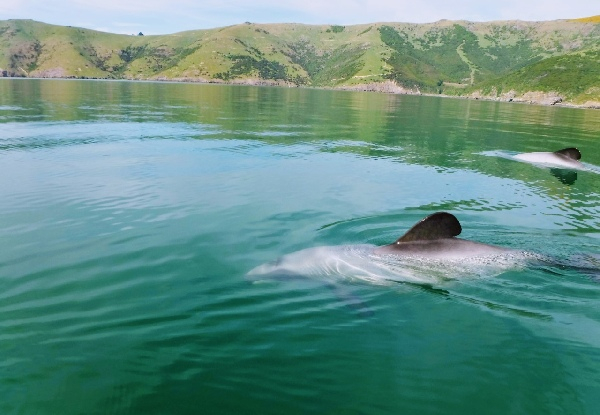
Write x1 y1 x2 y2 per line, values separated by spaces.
0 80 600 415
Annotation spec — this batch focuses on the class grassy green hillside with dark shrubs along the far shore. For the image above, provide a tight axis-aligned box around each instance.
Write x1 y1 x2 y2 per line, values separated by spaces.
0 18 600 103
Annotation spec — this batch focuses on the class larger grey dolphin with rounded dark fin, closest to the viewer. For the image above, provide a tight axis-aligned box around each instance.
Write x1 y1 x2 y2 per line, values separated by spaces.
247 212 539 284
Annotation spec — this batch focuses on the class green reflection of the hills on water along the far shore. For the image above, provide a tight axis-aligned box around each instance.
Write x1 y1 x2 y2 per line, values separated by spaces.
0 80 600 221
